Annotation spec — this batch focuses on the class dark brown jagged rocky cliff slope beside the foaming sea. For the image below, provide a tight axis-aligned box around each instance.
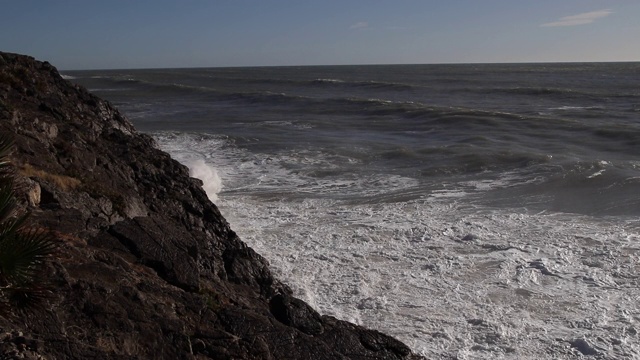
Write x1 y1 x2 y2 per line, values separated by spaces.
0 53 422 359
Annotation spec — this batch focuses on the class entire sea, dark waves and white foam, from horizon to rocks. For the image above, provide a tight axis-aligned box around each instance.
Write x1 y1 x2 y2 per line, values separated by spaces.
63 63 640 359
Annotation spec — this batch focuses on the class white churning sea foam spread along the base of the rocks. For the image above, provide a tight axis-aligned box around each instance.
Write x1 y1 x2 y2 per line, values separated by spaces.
156 133 640 359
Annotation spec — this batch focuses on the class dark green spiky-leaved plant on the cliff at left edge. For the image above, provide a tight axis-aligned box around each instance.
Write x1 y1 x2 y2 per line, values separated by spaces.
0 135 56 316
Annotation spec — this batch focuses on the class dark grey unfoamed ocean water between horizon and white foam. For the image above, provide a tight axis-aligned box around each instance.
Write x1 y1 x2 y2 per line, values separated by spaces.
69 63 640 215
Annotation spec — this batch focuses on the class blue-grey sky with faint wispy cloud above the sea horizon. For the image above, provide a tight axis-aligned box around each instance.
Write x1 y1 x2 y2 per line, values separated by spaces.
0 0 640 70
